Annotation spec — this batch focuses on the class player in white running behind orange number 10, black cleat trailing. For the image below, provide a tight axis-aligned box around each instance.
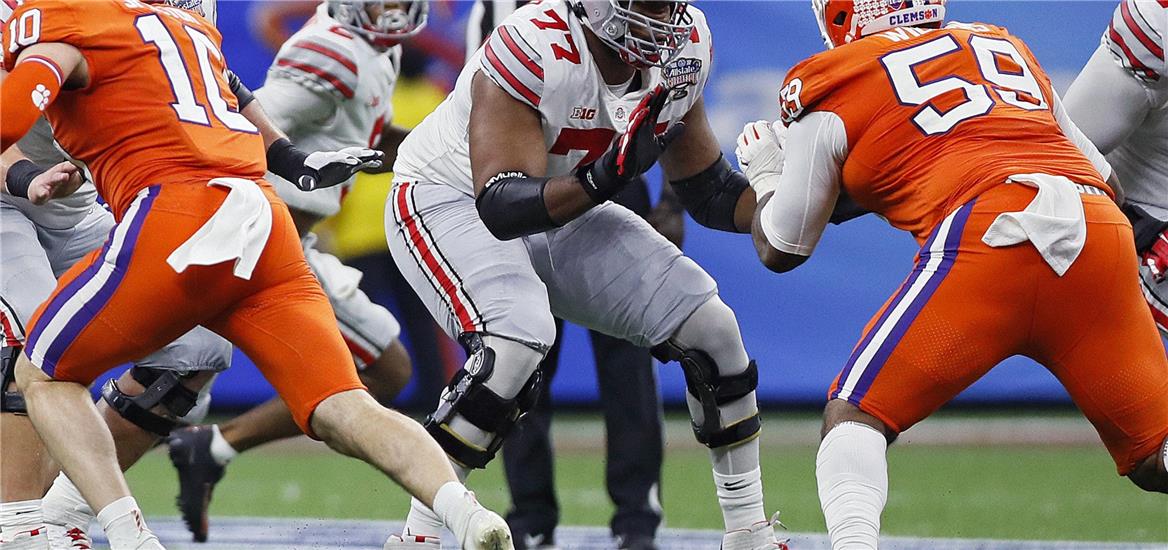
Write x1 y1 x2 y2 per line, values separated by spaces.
171 0 429 542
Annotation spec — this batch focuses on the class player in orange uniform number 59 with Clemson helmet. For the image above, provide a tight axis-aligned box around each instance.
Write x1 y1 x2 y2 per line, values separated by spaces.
738 0 1168 549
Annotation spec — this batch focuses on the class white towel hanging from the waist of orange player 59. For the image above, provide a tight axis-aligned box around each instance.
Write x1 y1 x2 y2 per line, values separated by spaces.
981 174 1087 277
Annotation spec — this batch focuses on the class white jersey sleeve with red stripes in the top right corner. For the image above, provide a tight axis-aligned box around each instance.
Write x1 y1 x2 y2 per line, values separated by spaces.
1103 0 1168 86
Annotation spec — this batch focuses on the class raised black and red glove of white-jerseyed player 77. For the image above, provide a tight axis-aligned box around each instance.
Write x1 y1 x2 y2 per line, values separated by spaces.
576 84 686 204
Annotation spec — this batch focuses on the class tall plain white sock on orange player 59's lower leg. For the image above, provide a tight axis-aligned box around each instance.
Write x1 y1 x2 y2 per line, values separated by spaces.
815 422 888 550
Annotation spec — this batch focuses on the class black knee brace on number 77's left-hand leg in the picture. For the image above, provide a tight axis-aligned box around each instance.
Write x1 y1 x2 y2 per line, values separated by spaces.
424 333 541 468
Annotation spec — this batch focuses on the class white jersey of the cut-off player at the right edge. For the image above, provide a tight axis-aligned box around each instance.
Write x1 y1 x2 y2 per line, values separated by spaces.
1100 0 1168 209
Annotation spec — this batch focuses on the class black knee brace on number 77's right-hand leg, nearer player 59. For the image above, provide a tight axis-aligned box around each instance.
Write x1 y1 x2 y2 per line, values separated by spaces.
652 342 763 448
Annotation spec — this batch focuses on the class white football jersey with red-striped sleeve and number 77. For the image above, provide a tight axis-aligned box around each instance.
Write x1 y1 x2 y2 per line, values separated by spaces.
394 0 712 196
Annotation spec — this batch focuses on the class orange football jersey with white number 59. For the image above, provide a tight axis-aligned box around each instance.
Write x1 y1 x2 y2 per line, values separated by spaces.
779 23 1107 242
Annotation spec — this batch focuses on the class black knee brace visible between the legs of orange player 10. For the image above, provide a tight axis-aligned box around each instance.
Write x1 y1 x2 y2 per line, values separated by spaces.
102 367 199 437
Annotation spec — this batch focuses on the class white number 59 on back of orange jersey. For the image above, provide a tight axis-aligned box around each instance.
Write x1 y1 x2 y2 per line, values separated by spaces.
880 34 1048 135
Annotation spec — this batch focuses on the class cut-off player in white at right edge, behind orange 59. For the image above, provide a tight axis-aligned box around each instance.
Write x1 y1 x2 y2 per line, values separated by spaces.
1066 0 1168 336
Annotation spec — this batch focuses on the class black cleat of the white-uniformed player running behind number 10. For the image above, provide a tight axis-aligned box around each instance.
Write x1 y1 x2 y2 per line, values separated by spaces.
167 426 224 542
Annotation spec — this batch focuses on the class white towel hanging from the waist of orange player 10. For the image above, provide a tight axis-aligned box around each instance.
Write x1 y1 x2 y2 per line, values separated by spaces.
166 177 272 279
